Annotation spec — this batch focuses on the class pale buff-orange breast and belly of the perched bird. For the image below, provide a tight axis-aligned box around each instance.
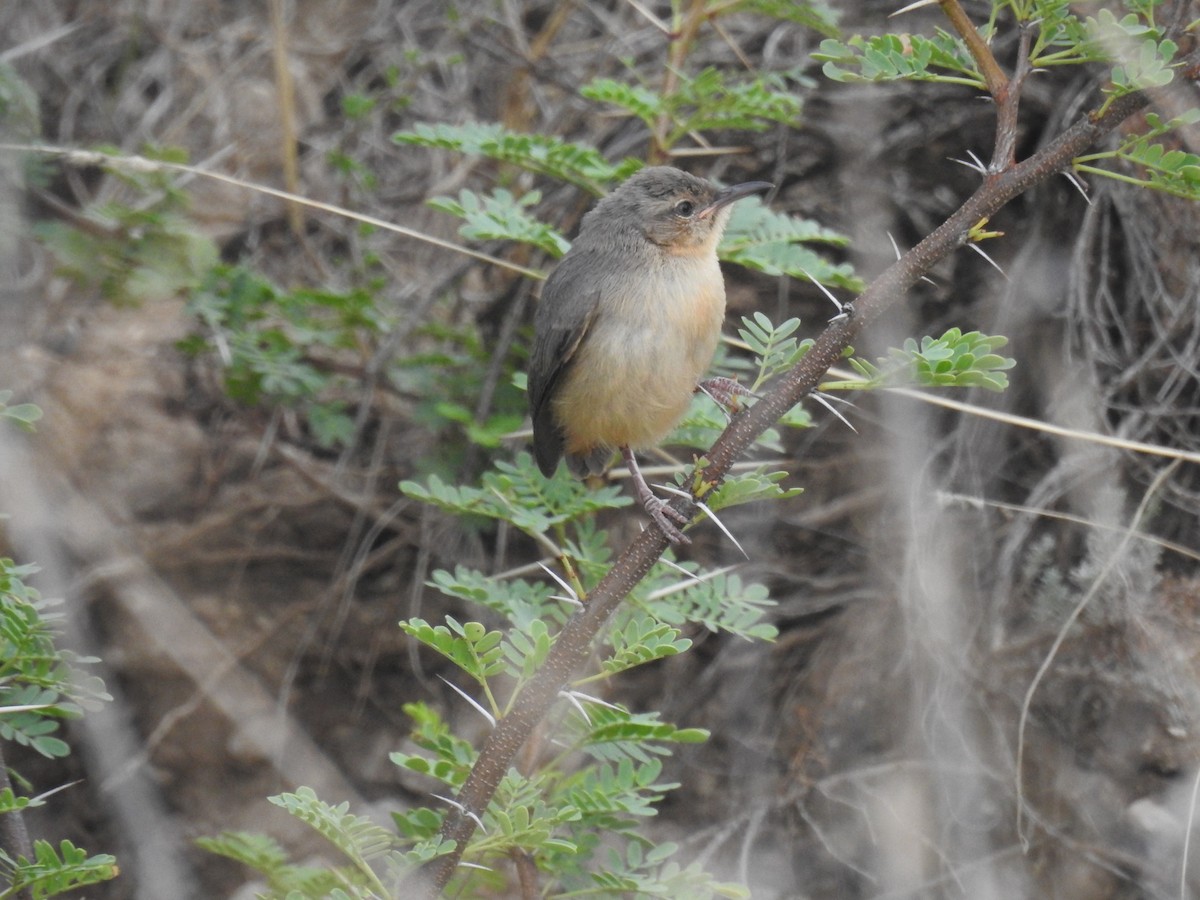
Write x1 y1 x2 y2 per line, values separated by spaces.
556 253 725 454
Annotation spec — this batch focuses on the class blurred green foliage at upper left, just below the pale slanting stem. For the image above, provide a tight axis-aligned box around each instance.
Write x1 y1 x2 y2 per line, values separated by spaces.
35 149 218 304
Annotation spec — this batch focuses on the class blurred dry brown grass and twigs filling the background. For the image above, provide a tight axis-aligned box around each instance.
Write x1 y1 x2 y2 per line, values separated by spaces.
0 0 1200 898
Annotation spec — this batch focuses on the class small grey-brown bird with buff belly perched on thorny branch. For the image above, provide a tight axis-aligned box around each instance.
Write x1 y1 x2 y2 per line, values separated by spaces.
528 166 772 544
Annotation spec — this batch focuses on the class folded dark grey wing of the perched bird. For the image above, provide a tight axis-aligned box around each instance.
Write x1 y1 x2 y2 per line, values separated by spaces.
528 253 600 478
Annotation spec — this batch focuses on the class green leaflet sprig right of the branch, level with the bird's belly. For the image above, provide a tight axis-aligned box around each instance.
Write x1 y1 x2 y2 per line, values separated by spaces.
835 328 1016 391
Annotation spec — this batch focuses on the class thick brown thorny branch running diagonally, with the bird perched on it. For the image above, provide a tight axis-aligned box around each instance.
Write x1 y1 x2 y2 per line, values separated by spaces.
427 77 1150 898
